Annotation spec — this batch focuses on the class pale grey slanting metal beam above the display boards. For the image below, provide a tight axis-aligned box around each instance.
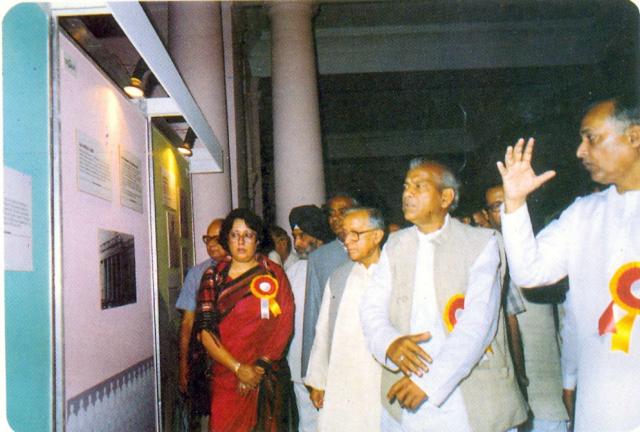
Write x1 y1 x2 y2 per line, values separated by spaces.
107 2 224 172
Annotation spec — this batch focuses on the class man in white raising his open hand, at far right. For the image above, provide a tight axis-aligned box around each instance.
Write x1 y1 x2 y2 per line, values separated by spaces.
498 100 640 432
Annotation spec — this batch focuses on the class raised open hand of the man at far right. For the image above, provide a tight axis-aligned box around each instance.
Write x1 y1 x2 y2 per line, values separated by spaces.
497 138 556 213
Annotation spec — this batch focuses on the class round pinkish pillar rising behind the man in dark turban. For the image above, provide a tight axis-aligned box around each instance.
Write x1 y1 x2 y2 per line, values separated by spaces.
269 2 325 229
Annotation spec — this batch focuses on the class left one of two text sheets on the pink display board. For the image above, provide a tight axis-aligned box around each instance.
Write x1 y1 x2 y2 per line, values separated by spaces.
76 131 112 201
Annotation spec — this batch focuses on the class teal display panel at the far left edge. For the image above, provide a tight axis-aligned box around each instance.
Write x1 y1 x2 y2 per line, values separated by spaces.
0 3 54 431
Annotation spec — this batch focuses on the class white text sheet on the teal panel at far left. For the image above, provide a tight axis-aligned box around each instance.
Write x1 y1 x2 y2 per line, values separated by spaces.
4 166 33 271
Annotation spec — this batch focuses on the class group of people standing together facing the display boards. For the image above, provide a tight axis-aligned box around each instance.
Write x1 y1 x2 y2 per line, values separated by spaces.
176 99 640 432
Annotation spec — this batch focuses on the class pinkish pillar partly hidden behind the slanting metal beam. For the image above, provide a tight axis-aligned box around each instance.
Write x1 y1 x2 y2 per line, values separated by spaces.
169 1 231 262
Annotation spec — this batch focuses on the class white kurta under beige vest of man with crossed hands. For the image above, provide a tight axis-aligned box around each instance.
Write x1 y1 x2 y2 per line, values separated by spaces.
361 217 500 432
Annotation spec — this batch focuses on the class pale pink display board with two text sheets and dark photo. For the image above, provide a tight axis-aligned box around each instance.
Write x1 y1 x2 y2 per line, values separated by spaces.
57 35 154 399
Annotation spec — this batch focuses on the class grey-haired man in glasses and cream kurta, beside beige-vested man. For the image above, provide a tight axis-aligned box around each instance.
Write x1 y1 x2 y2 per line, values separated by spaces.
305 207 384 432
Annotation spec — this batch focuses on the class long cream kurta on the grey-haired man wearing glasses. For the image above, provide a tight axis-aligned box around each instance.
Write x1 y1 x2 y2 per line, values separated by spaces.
305 264 382 432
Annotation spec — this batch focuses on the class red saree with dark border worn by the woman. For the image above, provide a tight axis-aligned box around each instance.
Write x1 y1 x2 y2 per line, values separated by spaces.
196 256 294 432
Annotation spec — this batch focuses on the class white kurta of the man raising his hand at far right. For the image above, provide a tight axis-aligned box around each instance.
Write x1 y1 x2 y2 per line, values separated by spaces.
502 186 640 432
